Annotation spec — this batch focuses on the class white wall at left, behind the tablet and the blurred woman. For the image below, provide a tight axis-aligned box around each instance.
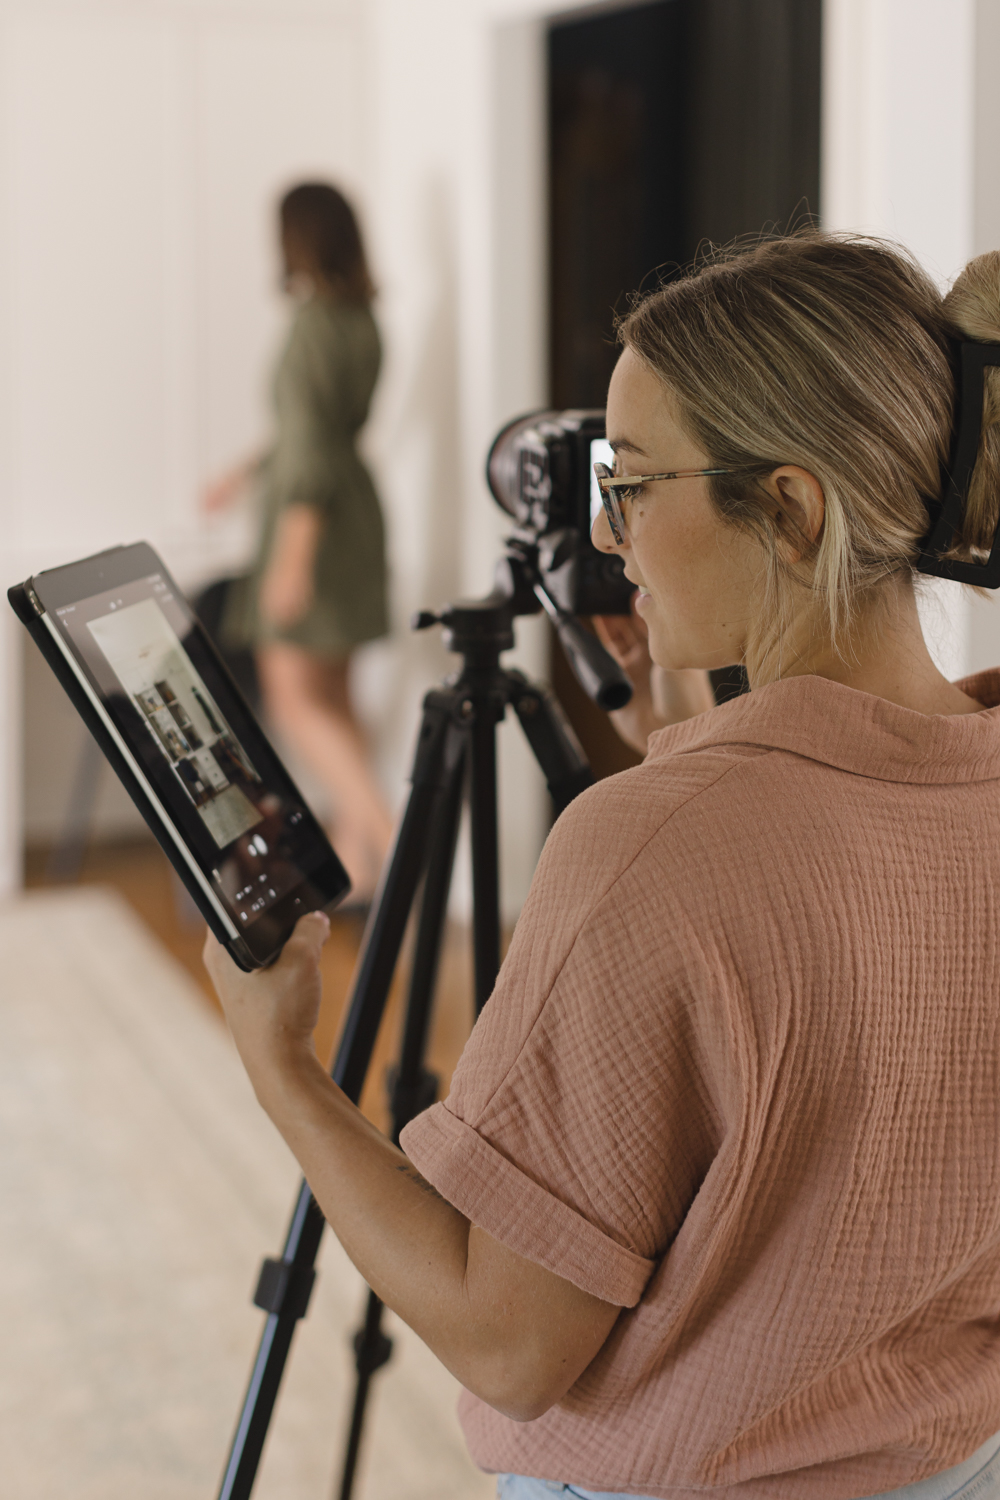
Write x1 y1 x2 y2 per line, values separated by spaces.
0 0 366 888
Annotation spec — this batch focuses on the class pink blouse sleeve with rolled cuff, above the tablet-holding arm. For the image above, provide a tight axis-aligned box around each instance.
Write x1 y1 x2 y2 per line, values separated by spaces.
402 768 728 1307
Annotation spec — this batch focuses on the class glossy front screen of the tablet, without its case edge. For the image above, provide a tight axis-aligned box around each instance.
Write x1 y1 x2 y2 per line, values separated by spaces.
34 546 346 948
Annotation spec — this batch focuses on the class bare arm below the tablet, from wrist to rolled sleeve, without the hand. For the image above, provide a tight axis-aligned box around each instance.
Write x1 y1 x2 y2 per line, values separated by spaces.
251 1058 618 1421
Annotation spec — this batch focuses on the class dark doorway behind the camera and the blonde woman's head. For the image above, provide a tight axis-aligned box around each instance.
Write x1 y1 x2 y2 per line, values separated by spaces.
549 0 822 776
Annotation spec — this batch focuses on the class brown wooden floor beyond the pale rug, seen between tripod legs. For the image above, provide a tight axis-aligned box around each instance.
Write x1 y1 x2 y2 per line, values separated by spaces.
25 839 472 1130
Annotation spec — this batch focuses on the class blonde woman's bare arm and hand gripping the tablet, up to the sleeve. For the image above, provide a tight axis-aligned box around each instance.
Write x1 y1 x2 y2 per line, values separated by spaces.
204 914 619 1422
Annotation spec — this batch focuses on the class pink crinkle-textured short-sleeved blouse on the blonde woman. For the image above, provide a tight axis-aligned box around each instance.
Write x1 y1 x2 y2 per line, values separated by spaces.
403 672 1000 1500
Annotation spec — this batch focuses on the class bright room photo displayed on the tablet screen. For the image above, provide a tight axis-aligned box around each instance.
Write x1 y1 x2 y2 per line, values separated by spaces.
87 599 265 849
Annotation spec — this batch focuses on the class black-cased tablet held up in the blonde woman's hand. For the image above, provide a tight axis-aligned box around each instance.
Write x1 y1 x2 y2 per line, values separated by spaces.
7 542 349 971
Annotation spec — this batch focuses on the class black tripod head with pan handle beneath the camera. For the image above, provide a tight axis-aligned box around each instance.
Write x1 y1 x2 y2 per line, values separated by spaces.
412 536 633 711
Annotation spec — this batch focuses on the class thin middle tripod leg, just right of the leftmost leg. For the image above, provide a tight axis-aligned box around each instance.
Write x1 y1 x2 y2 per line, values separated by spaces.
332 758 465 1500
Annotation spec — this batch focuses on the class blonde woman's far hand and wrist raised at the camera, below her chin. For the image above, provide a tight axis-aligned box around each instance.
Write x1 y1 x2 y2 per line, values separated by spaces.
594 599 715 755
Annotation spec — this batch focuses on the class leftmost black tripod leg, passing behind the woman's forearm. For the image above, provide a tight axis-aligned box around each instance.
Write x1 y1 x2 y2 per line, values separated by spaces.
219 690 462 1500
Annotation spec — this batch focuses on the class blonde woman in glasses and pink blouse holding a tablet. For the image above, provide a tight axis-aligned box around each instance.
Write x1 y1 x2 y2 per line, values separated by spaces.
207 233 1000 1500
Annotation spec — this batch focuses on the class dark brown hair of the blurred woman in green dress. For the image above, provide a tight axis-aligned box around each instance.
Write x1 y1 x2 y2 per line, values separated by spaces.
279 183 375 306
